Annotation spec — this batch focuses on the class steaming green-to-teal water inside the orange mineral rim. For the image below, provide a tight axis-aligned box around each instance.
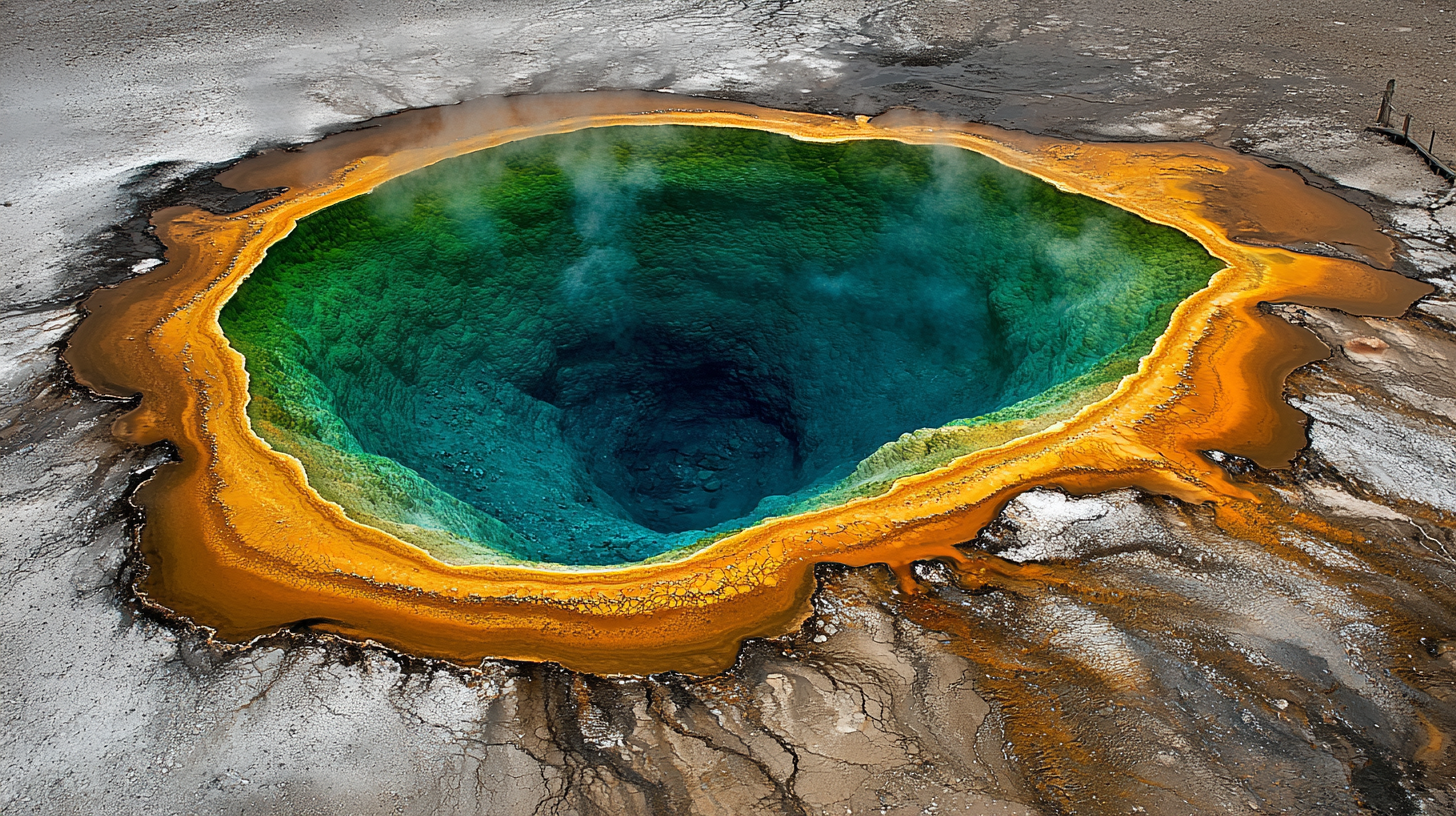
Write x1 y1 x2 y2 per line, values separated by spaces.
221 127 1220 565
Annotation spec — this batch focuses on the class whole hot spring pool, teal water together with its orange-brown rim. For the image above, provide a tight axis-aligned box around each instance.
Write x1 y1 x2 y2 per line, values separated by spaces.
66 93 1428 673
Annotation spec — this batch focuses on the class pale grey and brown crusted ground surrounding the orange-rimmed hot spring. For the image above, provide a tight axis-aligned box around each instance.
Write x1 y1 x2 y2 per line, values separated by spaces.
0 0 1456 816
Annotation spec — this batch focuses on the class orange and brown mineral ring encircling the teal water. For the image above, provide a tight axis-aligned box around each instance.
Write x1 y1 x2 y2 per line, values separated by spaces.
66 93 1430 673
